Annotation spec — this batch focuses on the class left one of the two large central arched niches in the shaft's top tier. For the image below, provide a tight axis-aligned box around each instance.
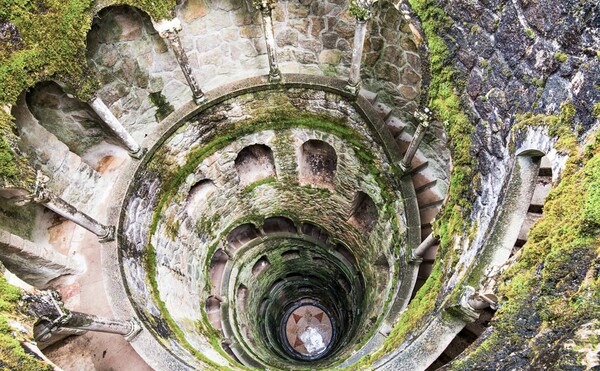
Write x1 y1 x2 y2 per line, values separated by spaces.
235 144 277 187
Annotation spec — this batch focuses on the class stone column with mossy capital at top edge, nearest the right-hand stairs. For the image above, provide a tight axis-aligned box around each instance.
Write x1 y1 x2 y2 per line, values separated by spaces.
346 0 377 95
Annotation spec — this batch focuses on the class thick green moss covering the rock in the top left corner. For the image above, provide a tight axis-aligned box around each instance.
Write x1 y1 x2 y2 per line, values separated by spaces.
0 0 176 192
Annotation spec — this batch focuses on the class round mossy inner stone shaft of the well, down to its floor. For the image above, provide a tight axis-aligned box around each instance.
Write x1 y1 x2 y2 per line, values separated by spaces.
119 88 408 369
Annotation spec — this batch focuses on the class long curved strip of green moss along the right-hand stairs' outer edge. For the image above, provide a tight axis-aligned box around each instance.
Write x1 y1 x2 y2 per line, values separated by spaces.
352 0 477 369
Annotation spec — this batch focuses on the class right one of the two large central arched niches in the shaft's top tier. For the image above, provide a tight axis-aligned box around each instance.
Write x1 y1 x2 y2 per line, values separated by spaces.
299 139 337 189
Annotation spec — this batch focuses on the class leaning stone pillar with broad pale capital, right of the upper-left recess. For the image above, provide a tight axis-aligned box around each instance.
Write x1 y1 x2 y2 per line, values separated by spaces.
152 18 204 104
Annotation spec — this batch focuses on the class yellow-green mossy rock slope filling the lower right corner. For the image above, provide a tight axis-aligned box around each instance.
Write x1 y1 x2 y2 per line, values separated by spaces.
453 120 600 370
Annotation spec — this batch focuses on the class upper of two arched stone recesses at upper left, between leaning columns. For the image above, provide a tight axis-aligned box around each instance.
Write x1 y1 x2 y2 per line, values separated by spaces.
87 7 180 142
